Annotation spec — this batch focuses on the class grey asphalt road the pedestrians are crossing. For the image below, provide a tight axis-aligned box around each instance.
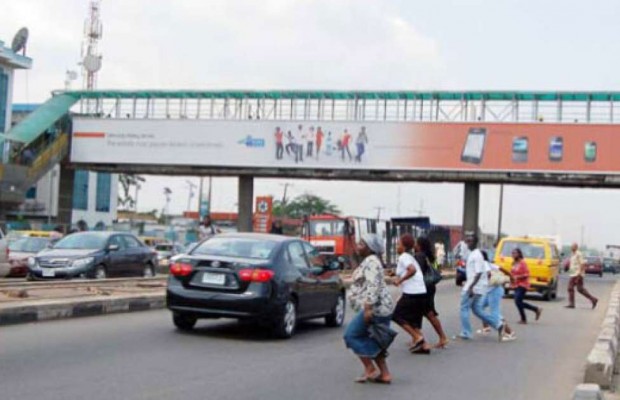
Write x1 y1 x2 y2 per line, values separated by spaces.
0 277 615 400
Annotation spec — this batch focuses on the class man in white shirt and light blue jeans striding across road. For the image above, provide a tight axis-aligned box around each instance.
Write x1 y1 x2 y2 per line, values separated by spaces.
459 234 504 341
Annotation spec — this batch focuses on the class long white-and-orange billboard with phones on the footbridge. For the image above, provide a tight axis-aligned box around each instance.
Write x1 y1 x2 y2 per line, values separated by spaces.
71 118 620 174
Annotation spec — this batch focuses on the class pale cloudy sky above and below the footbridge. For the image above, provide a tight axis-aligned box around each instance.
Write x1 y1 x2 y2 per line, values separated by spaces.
0 0 620 247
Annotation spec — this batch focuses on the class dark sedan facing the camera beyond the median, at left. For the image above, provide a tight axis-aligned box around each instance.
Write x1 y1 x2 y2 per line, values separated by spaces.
28 232 157 279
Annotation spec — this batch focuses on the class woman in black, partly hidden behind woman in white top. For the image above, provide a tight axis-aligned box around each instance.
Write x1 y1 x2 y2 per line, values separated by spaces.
415 236 448 349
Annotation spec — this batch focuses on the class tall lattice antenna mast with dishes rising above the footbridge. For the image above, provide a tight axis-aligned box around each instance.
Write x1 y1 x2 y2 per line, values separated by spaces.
82 0 103 90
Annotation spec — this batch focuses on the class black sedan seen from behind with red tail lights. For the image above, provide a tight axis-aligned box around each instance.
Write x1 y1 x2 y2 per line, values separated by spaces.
167 233 345 338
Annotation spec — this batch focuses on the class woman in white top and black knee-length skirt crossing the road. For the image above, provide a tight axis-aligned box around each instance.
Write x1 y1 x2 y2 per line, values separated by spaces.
392 233 431 354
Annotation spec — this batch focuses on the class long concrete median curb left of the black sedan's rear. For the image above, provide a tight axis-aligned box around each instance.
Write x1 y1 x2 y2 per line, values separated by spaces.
0 293 166 326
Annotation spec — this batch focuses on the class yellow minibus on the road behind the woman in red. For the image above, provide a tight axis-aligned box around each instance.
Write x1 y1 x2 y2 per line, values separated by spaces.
495 237 560 300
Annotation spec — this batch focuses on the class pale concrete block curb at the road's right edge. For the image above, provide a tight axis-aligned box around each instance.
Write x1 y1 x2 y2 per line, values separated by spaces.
575 282 620 390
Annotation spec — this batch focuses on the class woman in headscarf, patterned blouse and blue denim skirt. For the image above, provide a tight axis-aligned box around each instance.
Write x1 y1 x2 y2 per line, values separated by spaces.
344 234 394 383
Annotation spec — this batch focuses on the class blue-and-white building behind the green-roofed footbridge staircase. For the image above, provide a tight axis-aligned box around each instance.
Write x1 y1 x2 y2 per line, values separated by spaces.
11 104 118 229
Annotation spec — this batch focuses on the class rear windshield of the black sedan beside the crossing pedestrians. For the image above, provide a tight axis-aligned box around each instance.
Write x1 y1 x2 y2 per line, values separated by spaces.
190 237 277 260
